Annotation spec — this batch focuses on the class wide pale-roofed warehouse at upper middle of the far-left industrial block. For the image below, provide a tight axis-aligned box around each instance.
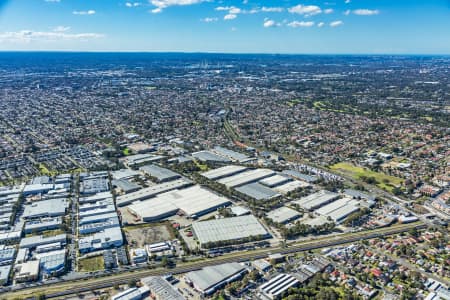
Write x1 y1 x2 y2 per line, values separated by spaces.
23 198 69 219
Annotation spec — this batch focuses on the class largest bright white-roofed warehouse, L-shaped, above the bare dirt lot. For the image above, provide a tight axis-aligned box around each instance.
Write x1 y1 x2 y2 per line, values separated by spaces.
128 185 231 222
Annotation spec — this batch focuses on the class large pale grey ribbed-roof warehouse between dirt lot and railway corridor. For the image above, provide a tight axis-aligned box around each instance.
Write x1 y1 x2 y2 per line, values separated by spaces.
192 215 270 247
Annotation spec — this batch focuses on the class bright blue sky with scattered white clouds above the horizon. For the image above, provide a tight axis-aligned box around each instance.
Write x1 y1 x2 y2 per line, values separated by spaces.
0 0 450 54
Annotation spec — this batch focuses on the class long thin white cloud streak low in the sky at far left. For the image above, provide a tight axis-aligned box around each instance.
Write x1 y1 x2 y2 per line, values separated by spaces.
0 30 104 43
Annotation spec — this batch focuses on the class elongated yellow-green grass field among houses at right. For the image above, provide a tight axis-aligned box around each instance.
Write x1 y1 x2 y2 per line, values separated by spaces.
330 162 403 192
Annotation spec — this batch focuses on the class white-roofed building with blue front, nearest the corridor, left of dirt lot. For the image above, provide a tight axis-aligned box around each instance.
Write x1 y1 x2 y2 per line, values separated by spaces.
78 227 123 253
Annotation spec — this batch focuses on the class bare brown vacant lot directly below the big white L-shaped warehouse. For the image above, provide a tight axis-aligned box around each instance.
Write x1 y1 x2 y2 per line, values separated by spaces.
124 223 174 248
